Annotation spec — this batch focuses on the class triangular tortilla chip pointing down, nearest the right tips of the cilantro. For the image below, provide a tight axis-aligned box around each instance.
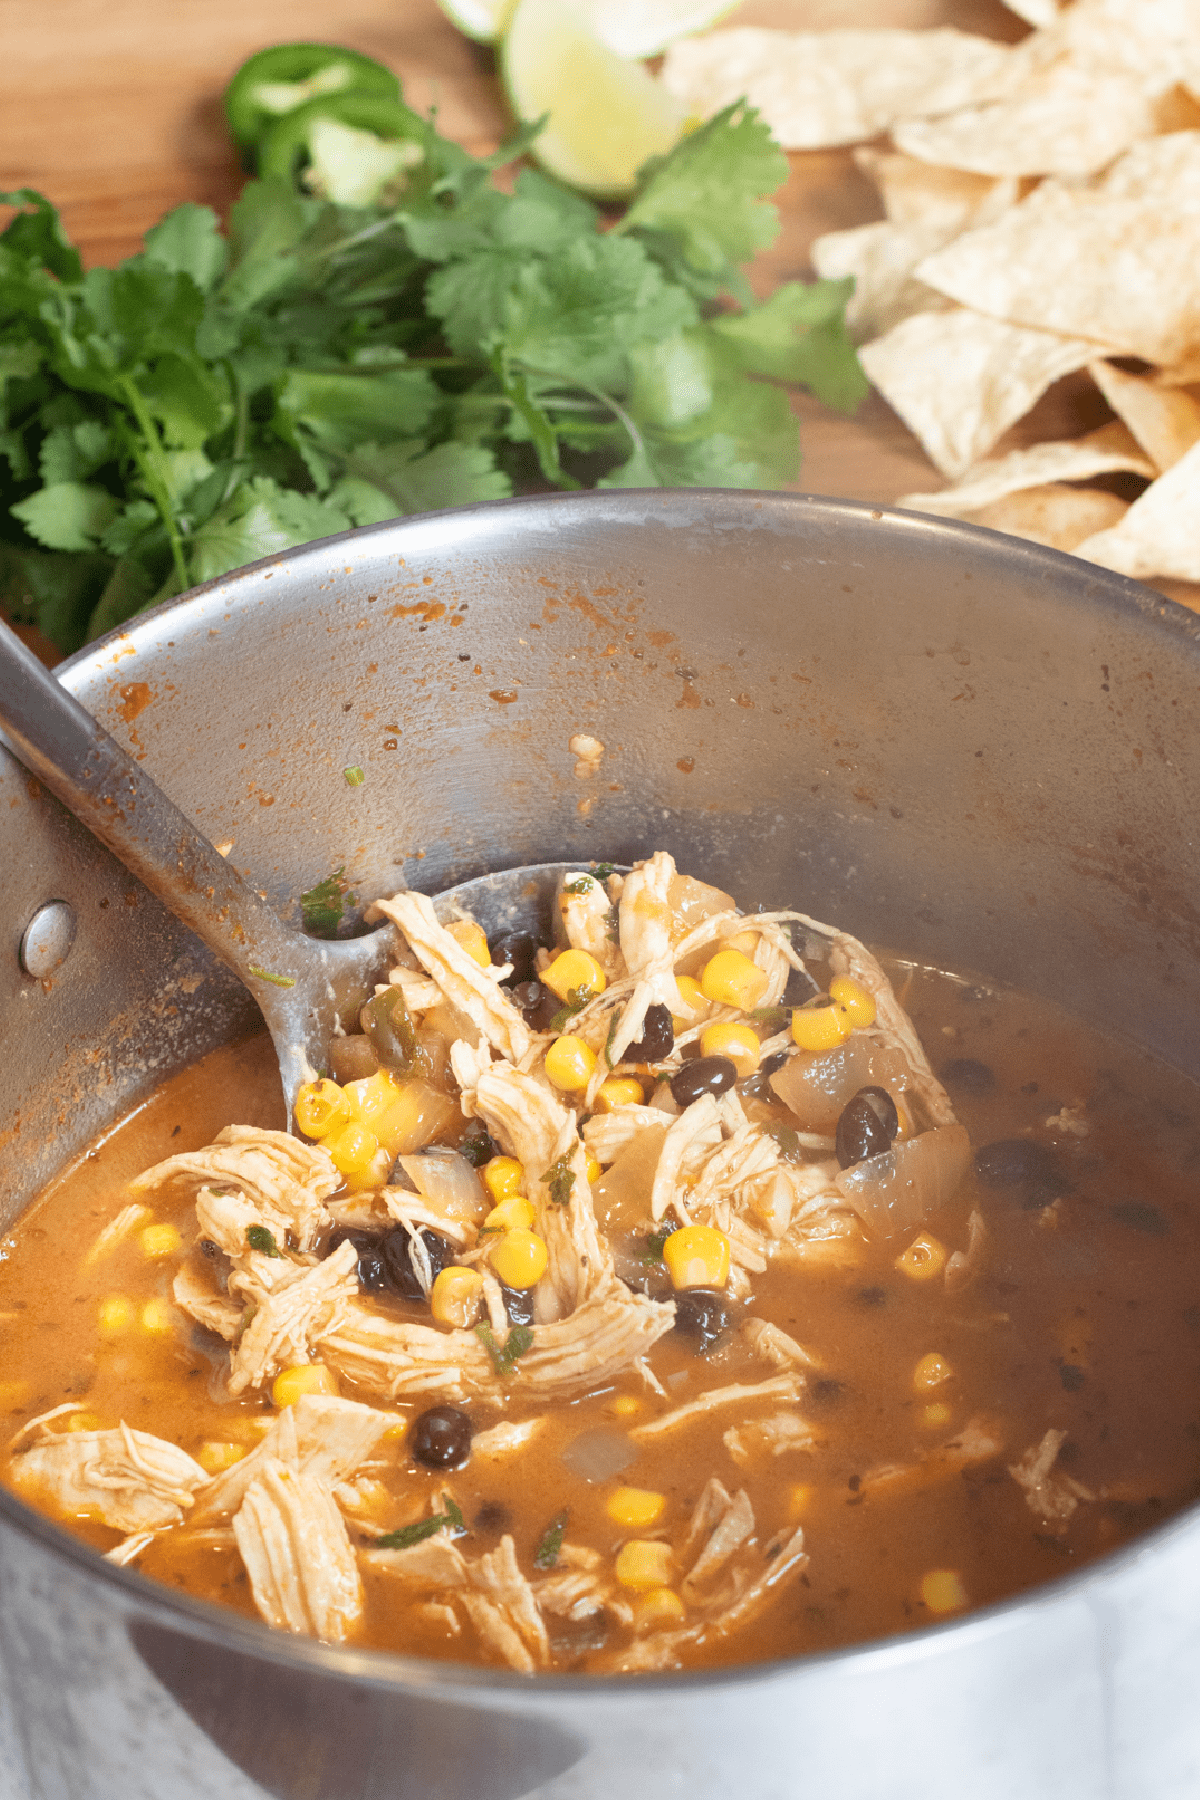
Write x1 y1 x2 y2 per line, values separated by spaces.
860 309 1094 479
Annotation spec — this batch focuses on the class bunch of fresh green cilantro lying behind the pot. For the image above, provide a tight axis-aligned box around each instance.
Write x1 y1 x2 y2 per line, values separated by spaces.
0 104 865 652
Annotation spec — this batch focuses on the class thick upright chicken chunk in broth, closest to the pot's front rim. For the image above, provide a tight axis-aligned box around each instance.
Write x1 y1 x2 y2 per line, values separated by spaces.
234 1458 363 1643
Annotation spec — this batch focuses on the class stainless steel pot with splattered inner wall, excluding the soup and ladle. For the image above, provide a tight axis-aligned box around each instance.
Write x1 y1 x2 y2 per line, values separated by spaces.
0 491 1200 1800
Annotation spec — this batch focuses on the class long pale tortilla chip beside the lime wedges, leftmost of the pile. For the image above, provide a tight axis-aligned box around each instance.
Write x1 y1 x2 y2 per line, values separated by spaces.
662 25 1015 149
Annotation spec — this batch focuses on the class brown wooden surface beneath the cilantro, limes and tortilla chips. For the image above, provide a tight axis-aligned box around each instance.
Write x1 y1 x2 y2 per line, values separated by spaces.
0 0 1200 658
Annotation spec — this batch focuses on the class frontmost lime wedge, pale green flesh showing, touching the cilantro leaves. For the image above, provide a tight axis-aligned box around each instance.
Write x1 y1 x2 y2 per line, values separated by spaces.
500 0 684 200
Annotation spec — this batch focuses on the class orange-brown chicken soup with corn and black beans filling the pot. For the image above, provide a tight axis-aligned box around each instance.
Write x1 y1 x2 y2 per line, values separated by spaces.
0 853 1200 1672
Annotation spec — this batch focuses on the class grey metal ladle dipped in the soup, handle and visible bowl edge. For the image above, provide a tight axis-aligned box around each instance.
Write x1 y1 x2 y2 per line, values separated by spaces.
0 621 563 1125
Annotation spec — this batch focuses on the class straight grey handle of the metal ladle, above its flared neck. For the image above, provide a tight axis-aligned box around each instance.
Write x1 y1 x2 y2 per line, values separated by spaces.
0 619 304 995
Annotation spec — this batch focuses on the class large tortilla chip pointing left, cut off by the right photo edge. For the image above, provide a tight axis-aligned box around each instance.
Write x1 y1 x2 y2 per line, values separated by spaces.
916 131 1200 364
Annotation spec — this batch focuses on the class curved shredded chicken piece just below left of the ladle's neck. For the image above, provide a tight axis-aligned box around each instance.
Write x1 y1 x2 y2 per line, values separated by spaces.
130 1125 342 1251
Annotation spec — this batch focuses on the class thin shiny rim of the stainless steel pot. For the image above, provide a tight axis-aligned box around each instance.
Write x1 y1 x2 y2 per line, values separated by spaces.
16 488 1200 1705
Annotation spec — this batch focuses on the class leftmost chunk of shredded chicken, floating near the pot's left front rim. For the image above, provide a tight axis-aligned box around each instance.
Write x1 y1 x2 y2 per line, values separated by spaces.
11 1420 209 1532
